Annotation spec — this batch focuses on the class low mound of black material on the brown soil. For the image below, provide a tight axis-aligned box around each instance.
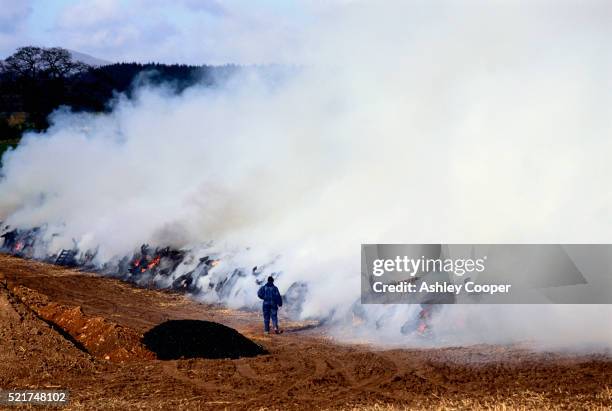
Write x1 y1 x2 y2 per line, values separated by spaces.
142 320 268 360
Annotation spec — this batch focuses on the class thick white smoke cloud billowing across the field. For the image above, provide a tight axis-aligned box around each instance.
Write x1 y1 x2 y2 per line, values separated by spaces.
0 1 612 346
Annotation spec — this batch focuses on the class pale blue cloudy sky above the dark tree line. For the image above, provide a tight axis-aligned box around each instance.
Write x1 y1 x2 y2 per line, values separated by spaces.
0 0 316 64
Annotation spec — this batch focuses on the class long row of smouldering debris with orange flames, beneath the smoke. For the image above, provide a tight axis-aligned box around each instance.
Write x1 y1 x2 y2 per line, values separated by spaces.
0 227 454 339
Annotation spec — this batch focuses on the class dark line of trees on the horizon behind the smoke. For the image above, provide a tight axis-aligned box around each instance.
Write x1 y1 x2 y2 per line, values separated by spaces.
0 46 238 140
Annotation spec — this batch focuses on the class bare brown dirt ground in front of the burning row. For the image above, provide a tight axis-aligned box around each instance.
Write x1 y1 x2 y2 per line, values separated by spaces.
0 255 612 410
